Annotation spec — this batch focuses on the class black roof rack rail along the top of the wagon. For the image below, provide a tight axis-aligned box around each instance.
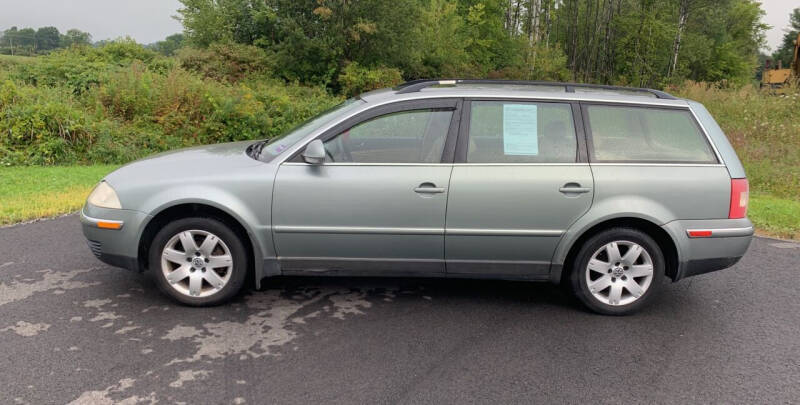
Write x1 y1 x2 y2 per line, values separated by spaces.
394 79 677 100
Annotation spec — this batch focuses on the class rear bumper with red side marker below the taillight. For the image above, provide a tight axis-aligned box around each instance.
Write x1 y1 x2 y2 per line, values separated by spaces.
664 218 753 281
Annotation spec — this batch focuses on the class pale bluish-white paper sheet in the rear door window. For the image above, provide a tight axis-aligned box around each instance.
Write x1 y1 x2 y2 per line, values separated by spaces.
503 104 539 156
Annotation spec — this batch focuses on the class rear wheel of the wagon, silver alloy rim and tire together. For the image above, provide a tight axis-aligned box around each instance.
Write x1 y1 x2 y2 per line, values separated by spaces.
570 228 665 315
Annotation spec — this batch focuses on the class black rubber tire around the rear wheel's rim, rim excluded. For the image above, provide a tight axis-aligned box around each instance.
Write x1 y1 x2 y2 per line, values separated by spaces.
570 228 665 315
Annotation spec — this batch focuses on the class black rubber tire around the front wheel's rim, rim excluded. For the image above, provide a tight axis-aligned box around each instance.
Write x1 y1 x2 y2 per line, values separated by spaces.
148 217 249 307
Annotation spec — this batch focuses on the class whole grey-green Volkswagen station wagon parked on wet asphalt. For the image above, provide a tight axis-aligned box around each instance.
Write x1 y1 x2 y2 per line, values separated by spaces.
81 80 753 314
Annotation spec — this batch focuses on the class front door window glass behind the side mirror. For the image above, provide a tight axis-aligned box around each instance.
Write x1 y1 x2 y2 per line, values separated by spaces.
325 109 453 163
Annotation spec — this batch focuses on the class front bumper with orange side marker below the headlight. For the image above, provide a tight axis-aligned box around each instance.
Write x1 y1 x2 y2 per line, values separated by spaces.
81 204 150 271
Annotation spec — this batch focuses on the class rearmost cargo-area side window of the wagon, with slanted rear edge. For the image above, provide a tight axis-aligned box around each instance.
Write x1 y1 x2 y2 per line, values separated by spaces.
584 105 717 163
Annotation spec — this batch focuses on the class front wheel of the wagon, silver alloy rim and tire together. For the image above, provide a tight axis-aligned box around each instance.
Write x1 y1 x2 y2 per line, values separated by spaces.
149 218 248 306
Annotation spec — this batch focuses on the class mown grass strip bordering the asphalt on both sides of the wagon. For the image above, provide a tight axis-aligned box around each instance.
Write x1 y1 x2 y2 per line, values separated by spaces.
0 165 800 239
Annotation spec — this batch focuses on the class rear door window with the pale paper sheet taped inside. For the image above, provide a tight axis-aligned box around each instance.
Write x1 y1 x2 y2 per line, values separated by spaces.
467 101 578 163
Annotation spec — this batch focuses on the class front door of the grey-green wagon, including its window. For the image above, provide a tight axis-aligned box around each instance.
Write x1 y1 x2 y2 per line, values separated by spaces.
272 100 458 274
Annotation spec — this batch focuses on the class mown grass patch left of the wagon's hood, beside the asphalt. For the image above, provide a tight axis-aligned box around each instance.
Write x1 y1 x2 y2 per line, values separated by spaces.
0 165 118 225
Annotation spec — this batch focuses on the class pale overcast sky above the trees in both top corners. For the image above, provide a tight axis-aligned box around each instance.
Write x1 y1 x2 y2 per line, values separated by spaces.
0 0 800 50
